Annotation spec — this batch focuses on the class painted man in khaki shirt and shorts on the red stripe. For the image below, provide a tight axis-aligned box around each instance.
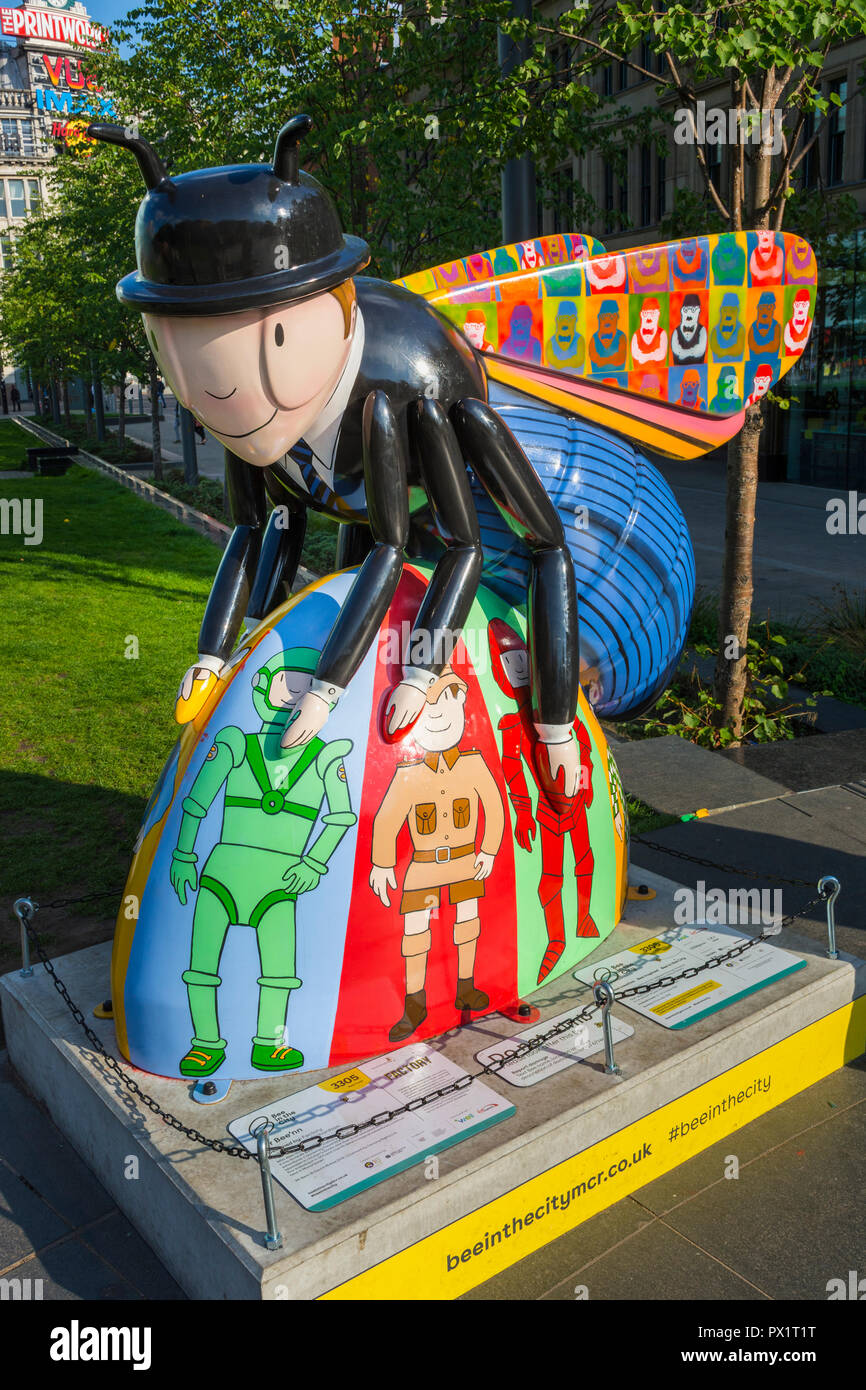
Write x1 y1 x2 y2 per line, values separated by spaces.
370 666 505 1043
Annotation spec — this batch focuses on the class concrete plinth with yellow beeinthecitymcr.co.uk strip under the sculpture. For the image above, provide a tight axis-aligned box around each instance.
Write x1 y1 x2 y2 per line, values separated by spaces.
0 870 866 1300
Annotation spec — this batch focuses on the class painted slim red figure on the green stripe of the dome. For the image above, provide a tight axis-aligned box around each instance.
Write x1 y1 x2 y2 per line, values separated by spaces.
488 617 598 984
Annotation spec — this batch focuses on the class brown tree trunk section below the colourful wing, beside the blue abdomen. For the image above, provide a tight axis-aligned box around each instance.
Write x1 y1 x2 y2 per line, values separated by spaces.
714 403 763 744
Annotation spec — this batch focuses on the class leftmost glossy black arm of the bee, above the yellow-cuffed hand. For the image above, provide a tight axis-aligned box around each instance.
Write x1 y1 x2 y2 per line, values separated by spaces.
199 449 267 662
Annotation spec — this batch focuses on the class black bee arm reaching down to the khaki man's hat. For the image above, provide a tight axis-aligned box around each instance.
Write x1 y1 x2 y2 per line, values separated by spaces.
410 399 482 676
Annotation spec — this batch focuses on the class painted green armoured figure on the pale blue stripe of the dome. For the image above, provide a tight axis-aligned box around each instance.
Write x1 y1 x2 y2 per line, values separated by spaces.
171 646 357 1077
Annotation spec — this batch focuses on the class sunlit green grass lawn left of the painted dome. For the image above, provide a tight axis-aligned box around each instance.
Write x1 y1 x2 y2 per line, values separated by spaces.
0 466 220 969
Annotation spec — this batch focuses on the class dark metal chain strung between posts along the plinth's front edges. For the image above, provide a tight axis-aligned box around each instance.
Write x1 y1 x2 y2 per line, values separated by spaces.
15 895 824 1162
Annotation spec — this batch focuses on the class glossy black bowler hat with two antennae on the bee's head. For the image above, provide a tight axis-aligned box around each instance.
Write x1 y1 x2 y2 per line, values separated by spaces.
88 115 370 314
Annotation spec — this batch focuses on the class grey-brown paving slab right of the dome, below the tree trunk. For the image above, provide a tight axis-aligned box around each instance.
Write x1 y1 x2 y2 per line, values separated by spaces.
616 734 789 816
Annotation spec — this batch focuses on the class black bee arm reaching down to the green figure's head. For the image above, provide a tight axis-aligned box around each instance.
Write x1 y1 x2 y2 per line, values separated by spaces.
316 391 409 688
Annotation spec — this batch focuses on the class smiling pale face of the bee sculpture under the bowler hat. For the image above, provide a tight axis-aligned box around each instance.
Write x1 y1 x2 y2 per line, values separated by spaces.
142 293 354 467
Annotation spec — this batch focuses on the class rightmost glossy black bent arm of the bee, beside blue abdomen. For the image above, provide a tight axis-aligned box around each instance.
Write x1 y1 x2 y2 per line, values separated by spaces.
450 400 580 726
